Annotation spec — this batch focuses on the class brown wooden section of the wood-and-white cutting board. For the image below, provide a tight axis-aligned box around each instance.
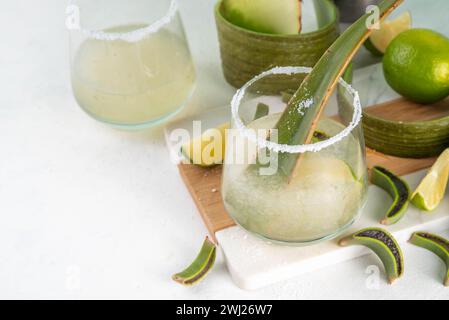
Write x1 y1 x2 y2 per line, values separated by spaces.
179 98 440 239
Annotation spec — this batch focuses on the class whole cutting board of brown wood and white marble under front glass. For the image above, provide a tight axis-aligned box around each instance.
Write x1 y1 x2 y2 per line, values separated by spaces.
165 93 449 290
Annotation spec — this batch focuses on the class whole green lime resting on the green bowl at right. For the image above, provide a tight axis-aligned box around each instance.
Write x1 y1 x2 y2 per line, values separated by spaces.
383 29 449 104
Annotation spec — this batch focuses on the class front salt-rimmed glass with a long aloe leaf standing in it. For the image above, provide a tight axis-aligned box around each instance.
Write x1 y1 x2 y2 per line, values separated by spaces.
222 67 367 245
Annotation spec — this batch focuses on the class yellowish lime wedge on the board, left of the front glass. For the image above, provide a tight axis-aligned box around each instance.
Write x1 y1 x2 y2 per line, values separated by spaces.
181 123 230 167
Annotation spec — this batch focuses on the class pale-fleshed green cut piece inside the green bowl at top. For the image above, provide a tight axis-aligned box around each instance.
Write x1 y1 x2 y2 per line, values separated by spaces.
223 0 301 34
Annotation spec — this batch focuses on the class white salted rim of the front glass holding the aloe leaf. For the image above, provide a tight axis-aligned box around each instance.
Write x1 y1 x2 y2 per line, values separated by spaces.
231 67 362 153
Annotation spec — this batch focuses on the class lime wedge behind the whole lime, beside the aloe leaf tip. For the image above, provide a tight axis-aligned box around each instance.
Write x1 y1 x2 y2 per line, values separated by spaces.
365 11 412 56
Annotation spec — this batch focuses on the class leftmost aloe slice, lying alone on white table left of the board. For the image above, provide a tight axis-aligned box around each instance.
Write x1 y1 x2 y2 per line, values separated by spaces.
172 237 217 286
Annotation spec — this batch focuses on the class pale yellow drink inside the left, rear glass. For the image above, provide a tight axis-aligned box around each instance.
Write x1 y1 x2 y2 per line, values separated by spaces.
72 25 195 127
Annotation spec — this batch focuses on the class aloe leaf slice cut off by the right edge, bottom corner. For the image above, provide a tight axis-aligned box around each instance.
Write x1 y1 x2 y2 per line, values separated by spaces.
410 232 449 287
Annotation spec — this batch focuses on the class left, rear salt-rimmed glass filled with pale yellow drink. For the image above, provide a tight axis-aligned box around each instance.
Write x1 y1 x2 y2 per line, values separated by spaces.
67 0 195 129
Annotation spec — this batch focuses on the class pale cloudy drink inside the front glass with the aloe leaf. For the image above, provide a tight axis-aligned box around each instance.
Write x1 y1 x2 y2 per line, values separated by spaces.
222 114 367 243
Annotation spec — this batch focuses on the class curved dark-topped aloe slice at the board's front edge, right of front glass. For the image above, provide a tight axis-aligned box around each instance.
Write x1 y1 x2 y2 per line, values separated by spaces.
339 228 404 284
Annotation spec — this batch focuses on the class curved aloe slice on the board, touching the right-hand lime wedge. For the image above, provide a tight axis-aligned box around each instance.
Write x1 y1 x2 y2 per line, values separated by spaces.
371 167 410 225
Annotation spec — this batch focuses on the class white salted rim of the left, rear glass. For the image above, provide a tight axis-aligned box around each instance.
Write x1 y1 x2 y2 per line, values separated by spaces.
70 0 178 42
